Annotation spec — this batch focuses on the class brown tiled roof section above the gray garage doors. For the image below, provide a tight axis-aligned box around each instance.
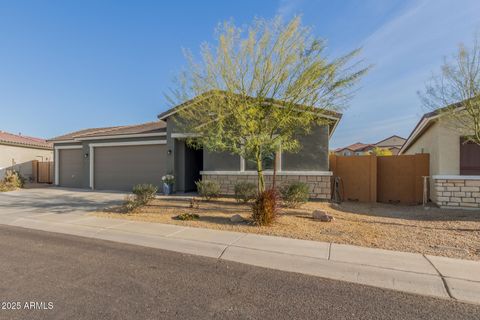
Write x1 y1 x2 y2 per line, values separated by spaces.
49 121 166 142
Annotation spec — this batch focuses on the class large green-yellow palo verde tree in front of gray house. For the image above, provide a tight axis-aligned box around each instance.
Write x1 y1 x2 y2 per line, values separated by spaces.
167 17 366 192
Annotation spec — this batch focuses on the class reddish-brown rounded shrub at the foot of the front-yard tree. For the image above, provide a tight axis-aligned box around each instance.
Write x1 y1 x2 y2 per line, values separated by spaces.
252 189 278 226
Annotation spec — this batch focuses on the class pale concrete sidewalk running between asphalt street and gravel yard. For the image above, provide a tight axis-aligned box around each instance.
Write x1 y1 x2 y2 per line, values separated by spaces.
0 213 480 304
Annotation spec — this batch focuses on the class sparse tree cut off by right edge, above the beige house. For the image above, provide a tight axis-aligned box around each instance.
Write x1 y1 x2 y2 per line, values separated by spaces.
419 36 480 144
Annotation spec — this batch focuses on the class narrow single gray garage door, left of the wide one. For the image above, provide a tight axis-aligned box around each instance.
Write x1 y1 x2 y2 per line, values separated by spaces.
58 149 83 188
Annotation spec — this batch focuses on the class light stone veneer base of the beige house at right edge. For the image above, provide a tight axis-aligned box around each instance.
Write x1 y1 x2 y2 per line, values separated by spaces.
432 175 480 209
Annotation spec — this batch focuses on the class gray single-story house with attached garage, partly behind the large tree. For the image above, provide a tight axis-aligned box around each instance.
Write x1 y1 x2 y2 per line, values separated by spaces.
51 95 341 199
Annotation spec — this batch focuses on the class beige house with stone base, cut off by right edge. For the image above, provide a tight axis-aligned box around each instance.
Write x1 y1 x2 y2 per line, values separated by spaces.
400 107 480 208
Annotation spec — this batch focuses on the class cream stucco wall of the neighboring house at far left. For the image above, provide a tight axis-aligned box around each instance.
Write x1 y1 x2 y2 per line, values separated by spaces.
0 145 53 179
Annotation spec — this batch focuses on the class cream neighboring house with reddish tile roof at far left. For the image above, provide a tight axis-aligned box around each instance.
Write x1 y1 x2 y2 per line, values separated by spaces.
0 131 53 179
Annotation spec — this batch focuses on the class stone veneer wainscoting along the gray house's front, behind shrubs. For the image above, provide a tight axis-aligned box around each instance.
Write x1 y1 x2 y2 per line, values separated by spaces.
201 171 332 200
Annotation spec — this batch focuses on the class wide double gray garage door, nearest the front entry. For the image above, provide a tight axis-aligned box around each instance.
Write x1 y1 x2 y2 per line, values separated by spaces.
94 145 166 191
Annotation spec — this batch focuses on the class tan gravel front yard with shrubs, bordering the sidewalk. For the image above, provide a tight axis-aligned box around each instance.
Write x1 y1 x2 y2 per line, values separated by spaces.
94 196 480 260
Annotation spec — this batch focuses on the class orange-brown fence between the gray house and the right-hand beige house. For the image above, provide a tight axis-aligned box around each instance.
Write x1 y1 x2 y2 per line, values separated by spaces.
330 154 429 204
